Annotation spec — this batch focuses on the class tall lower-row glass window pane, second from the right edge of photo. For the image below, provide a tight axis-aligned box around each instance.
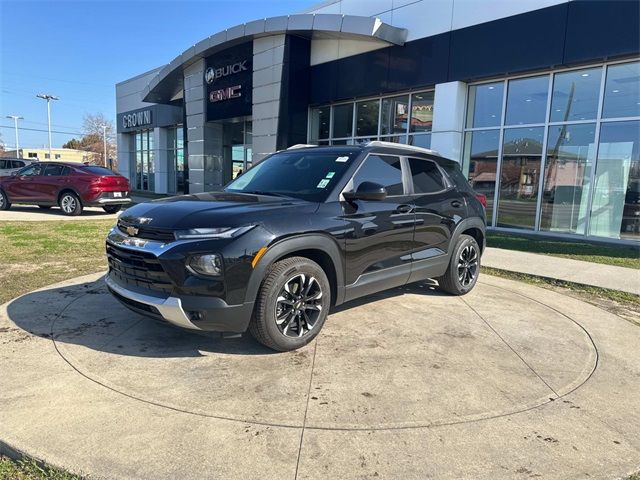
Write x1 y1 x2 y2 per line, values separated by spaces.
540 124 595 234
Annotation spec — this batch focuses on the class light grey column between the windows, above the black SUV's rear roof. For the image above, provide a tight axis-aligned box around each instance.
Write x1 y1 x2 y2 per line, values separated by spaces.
431 82 467 163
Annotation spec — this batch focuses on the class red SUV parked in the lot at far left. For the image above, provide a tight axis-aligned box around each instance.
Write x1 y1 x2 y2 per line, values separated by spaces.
0 162 131 215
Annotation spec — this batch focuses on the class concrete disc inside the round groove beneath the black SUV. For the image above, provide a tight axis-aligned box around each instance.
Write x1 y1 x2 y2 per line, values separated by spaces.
44 278 596 429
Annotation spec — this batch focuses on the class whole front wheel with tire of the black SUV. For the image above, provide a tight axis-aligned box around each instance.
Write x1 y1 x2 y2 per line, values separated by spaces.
249 257 331 352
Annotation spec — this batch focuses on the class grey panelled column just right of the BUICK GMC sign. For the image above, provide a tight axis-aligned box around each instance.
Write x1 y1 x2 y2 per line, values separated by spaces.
252 35 285 163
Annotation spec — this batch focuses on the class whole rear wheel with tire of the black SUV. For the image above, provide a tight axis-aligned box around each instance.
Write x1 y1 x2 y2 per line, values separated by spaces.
437 235 480 295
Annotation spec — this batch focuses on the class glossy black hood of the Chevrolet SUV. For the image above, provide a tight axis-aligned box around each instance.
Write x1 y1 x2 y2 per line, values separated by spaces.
120 192 318 230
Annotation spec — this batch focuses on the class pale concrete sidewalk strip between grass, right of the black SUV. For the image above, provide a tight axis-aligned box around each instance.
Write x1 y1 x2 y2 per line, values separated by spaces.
482 247 640 295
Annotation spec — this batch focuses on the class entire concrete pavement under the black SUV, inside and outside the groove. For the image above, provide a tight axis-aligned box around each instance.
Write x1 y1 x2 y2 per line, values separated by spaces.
0 275 640 479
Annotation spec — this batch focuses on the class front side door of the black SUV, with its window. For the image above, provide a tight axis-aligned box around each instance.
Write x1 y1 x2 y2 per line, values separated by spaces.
343 154 415 300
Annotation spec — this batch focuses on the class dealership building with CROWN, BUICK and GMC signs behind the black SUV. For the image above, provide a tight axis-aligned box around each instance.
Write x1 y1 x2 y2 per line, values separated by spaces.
116 0 640 242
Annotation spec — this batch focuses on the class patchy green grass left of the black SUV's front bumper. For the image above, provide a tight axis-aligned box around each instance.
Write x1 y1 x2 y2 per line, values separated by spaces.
0 220 114 304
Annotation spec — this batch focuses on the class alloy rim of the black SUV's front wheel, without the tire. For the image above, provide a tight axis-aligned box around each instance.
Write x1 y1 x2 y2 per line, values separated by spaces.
275 273 322 337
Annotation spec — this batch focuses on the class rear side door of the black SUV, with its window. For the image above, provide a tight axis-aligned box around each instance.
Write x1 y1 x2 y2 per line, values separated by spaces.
407 157 466 281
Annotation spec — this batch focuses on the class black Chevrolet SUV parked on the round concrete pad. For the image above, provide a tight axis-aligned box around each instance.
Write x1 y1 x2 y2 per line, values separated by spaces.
106 142 486 351
